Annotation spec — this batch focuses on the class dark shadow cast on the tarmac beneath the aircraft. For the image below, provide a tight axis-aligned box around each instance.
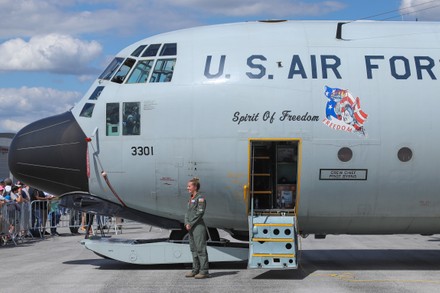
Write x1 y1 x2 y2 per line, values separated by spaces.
65 249 440 280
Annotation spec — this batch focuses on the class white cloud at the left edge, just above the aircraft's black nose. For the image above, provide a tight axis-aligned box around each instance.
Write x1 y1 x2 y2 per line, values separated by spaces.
0 87 81 132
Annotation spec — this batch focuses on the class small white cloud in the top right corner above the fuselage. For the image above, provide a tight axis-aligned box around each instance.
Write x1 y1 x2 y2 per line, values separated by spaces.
400 0 440 21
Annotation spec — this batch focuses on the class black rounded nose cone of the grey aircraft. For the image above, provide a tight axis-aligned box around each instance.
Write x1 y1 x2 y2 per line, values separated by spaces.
8 112 89 195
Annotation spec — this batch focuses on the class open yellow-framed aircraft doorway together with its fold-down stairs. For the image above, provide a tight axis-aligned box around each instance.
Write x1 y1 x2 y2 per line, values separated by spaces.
248 139 301 268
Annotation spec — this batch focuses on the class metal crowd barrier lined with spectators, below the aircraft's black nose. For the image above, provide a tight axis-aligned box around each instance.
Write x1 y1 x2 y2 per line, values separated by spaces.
0 199 123 245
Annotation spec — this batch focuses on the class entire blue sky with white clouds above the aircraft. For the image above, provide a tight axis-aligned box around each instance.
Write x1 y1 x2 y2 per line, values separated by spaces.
0 0 440 133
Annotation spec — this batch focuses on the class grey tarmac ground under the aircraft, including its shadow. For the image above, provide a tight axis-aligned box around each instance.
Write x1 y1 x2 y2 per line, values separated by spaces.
0 223 440 293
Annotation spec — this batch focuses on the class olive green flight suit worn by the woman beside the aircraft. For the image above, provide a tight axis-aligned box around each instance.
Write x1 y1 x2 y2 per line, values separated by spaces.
185 193 209 275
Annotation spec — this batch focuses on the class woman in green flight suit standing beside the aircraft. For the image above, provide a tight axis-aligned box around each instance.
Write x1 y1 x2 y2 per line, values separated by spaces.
185 178 209 279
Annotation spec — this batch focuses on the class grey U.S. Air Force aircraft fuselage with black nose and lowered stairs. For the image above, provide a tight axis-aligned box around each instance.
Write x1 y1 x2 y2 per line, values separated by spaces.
9 21 440 267
